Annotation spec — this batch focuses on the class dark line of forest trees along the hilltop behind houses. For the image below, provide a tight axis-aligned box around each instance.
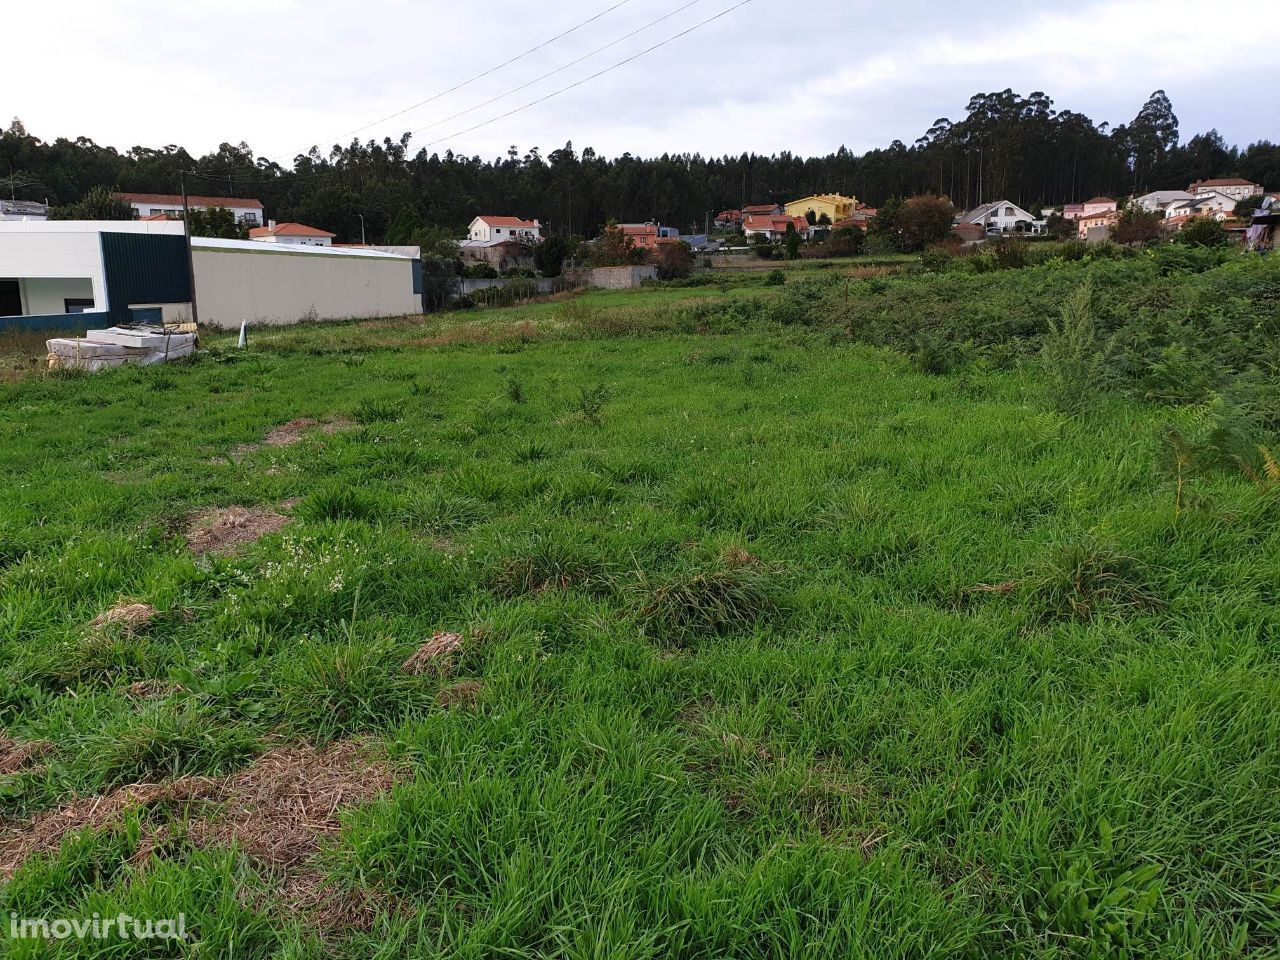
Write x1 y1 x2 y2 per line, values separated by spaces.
0 90 1280 242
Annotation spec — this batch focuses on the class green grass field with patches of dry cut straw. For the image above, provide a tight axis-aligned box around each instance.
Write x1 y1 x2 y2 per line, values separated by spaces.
0 257 1280 960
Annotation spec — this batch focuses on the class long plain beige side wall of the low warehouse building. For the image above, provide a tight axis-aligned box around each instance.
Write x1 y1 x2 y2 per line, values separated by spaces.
193 244 421 330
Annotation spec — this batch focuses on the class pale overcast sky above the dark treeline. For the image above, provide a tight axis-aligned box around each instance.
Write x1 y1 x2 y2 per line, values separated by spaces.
0 0 1280 161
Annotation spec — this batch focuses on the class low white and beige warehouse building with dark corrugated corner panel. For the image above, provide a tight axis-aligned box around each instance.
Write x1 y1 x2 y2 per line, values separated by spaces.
0 220 422 330
